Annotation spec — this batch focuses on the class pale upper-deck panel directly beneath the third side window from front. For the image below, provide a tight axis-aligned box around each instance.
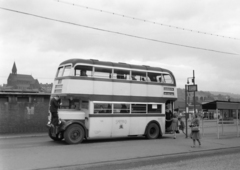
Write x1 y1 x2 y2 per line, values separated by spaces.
113 82 130 96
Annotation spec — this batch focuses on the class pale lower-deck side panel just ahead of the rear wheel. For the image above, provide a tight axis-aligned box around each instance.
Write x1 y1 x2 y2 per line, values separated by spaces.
130 117 147 135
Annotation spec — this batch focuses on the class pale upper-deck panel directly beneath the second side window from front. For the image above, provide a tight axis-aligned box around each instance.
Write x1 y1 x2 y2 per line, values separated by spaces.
93 81 113 95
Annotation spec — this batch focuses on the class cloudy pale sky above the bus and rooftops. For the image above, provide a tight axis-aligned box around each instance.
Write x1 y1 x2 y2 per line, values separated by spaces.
0 0 240 94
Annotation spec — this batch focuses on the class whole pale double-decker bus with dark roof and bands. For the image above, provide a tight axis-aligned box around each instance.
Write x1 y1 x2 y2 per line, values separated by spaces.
49 59 177 144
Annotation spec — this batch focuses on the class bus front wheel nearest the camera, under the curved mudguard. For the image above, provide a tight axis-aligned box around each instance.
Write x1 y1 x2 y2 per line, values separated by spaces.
64 125 84 144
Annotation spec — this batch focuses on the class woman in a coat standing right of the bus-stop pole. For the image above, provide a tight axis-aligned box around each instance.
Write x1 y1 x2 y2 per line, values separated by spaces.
190 114 201 148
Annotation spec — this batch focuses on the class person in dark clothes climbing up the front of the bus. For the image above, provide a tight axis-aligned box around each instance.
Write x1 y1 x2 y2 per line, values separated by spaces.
49 96 61 126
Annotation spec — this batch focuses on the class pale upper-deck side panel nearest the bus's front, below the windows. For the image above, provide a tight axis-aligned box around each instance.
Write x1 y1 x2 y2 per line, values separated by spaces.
62 79 93 94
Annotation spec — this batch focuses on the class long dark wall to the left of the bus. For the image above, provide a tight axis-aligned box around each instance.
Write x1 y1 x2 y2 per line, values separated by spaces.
0 93 50 134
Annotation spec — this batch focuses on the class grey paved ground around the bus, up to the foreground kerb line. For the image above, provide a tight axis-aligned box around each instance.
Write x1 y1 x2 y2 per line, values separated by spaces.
0 122 240 170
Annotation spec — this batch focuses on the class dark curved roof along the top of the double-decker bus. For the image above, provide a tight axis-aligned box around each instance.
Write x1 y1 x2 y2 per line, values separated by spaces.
60 59 173 75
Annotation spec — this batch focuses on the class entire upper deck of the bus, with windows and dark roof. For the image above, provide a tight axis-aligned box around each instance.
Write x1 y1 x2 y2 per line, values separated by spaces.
52 59 177 102
